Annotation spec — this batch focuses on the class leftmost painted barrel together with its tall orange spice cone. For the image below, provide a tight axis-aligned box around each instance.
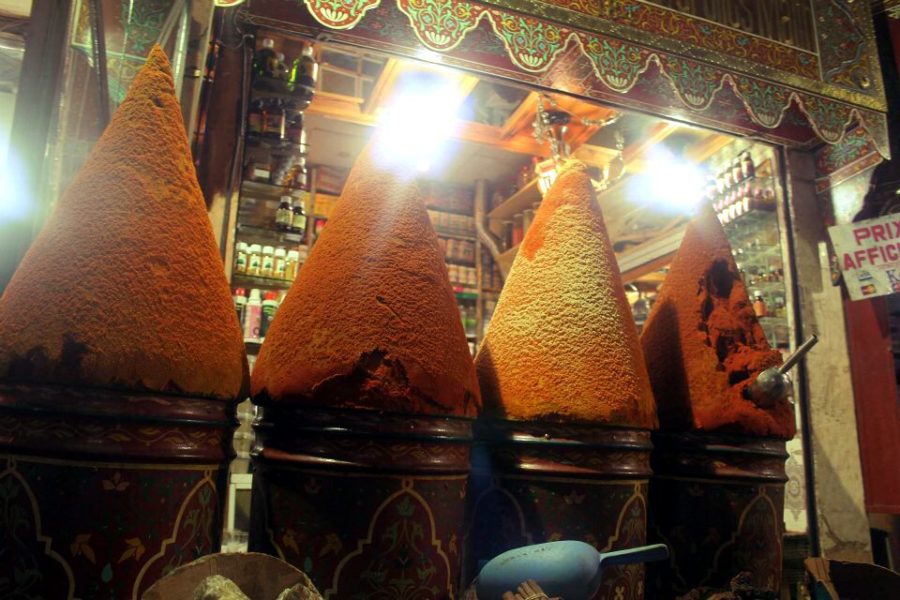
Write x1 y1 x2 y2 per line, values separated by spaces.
0 47 247 598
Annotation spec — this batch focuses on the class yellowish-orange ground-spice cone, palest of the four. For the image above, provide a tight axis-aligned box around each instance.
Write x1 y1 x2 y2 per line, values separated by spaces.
475 163 656 428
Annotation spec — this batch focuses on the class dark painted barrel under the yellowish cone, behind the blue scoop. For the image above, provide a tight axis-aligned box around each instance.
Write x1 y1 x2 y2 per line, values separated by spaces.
464 421 652 600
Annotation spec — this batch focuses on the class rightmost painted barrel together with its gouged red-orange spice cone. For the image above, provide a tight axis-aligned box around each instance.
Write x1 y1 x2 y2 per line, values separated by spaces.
641 208 795 598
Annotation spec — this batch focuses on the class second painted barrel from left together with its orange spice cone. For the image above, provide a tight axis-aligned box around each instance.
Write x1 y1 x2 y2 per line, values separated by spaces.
249 142 479 598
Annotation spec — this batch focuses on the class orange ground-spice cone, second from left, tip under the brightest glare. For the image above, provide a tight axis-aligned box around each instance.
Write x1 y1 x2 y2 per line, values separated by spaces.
252 143 480 416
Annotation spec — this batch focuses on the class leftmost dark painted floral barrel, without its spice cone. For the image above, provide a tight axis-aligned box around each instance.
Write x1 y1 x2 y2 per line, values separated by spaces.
0 385 236 600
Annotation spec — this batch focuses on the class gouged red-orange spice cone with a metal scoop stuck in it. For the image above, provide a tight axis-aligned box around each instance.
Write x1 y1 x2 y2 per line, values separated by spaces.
641 208 795 438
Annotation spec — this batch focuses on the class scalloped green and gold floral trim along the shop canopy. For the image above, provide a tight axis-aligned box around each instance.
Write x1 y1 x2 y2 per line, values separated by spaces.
302 0 890 158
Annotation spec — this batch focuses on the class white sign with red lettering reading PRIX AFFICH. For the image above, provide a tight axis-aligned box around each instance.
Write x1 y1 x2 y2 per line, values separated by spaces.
828 215 900 300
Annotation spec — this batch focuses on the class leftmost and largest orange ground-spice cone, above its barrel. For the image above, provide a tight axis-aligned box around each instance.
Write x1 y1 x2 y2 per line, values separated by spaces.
0 47 248 398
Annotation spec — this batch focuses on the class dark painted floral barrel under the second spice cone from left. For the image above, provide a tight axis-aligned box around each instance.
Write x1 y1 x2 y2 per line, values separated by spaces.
249 406 472 600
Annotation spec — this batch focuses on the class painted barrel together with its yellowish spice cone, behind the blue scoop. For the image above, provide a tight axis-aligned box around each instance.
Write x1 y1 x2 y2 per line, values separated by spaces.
465 163 656 600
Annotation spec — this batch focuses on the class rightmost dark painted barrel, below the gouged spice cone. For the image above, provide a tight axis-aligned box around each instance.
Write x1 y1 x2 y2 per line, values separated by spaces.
647 432 788 599
